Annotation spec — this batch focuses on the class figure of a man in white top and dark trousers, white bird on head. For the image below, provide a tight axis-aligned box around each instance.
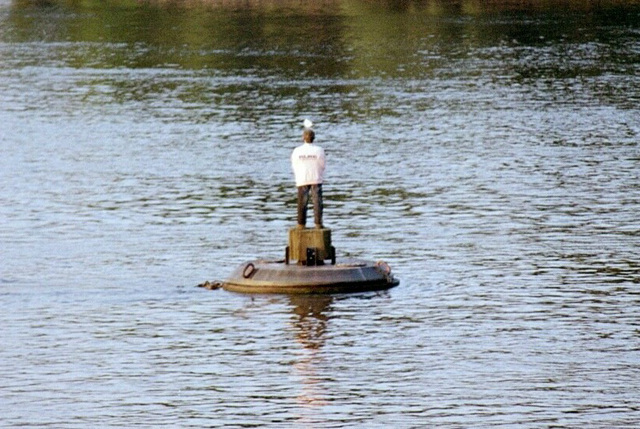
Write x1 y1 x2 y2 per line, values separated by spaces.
291 119 325 228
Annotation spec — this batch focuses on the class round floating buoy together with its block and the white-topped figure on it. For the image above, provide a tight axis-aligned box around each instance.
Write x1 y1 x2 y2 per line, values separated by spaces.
222 119 400 294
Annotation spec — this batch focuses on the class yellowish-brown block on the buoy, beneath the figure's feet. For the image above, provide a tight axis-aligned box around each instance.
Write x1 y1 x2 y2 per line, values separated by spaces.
287 228 335 265
